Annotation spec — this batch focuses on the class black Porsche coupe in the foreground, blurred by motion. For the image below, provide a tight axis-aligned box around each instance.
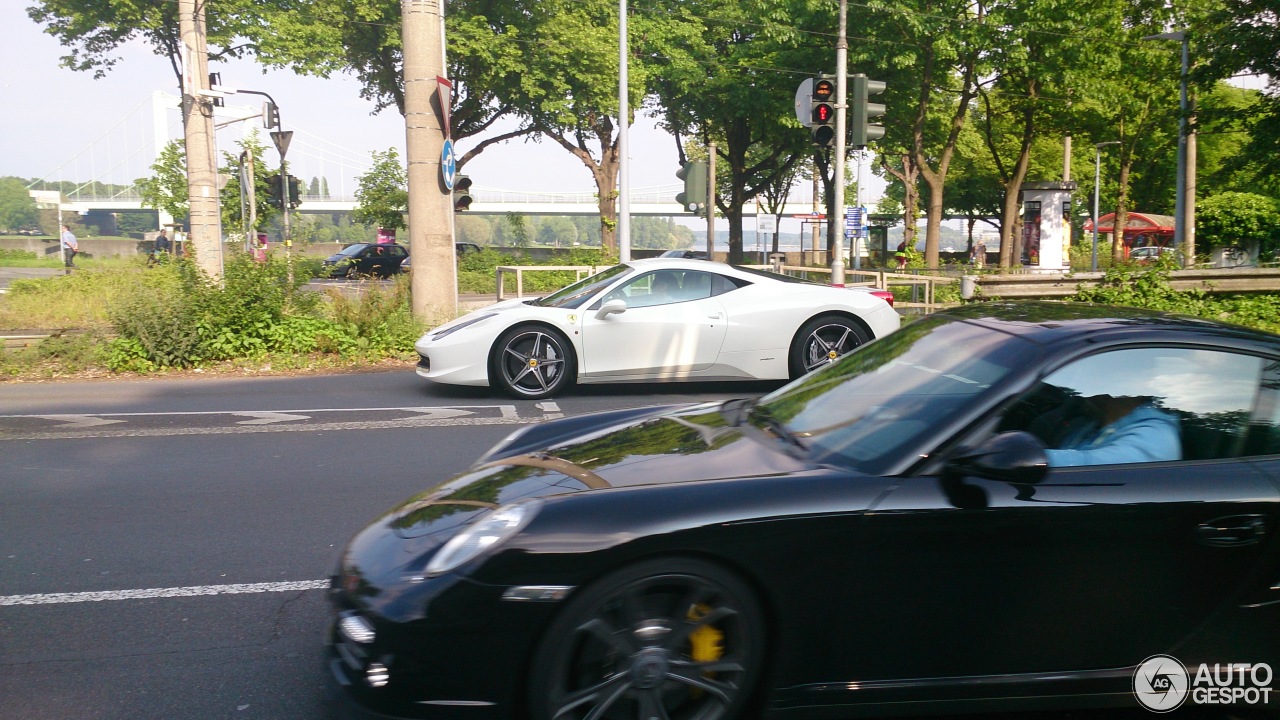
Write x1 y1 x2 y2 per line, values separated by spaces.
329 304 1280 720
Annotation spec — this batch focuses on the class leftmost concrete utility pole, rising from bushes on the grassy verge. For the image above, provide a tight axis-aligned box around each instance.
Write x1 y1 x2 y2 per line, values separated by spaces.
178 0 223 281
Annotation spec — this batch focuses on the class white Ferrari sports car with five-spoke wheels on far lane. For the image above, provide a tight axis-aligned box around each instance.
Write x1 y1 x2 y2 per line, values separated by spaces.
415 259 900 398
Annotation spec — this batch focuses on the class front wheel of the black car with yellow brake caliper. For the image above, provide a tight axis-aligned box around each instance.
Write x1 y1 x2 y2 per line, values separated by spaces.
530 560 764 720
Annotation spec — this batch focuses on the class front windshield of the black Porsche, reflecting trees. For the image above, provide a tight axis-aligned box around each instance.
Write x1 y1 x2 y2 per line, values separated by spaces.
750 316 1032 474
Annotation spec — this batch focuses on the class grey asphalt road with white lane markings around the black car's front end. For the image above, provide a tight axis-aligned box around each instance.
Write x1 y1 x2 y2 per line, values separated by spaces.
0 370 777 720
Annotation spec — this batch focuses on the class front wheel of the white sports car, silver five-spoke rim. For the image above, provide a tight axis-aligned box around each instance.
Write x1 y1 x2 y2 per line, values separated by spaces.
489 325 576 400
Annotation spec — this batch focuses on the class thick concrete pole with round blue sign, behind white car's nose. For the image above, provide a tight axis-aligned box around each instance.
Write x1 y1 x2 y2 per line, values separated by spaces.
401 0 458 320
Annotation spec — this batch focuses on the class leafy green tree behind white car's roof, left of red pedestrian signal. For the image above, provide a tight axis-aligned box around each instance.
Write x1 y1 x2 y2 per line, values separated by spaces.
650 0 819 263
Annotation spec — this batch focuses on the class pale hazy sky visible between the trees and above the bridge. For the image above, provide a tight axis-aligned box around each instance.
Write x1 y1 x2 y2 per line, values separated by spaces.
0 0 680 195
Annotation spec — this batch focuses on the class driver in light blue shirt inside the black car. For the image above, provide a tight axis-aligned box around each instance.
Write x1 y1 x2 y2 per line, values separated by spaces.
1044 395 1183 468
